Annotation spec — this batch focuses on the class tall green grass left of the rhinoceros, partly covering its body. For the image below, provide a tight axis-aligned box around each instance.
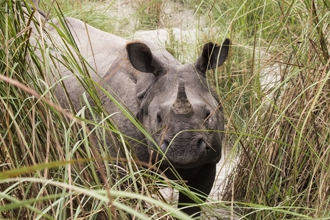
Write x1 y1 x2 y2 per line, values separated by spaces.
0 1 188 219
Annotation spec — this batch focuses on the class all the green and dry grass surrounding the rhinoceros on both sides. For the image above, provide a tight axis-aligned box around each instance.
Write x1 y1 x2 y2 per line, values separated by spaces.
0 0 330 219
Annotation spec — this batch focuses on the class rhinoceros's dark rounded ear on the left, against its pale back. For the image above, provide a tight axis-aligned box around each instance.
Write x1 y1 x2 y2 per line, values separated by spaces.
126 42 162 75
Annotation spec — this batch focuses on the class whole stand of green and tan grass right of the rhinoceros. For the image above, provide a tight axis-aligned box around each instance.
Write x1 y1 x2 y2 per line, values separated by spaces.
220 1 330 219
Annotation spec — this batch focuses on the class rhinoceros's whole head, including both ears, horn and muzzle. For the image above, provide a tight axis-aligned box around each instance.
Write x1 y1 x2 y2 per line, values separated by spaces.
126 39 230 169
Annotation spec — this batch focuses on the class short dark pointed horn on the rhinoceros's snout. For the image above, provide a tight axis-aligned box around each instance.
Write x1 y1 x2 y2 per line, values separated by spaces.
173 78 192 115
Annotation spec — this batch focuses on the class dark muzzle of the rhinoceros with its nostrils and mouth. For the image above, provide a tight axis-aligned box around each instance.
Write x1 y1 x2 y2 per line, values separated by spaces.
156 138 210 168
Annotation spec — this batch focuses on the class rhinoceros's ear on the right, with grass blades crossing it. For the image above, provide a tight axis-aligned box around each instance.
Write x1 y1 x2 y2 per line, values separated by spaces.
195 39 230 73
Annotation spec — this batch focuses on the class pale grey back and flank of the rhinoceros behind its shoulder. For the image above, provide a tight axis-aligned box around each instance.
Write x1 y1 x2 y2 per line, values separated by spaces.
41 18 126 110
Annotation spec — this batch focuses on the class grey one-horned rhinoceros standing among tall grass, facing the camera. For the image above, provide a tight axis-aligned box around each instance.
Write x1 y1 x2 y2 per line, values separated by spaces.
33 13 230 215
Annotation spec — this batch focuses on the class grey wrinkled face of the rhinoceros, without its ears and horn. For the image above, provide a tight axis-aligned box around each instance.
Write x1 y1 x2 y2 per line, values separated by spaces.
138 64 223 168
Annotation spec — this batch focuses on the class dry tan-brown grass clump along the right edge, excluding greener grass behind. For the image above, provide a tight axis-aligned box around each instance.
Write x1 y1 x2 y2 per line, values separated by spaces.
219 1 330 219
